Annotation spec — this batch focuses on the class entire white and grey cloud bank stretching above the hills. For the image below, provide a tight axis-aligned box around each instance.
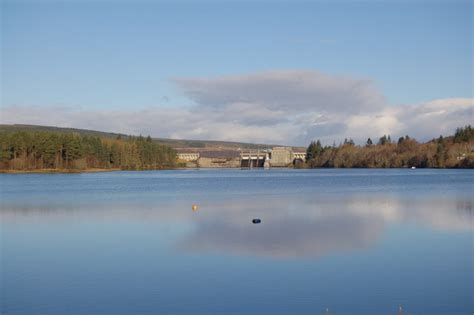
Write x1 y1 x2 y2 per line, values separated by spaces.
1 70 474 145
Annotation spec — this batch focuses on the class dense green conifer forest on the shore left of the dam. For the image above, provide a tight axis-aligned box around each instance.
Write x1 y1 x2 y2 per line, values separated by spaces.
0 131 176 171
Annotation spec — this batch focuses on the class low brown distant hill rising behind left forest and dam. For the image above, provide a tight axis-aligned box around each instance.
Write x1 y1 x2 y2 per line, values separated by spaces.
0 124 296 151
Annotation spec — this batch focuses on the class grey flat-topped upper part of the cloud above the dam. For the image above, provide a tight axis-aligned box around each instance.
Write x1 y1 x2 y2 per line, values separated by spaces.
173 70 384 113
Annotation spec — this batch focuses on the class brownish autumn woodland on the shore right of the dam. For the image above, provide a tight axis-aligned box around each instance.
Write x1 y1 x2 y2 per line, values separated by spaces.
304 125 474 168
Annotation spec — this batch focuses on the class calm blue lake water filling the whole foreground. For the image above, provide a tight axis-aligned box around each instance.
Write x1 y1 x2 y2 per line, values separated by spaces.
0 169 474 315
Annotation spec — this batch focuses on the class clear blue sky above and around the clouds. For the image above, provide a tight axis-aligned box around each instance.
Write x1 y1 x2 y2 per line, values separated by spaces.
1 1 473 144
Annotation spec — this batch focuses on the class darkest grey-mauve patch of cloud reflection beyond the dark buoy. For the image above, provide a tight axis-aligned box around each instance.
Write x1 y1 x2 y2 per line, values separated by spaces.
181 215 383 257
